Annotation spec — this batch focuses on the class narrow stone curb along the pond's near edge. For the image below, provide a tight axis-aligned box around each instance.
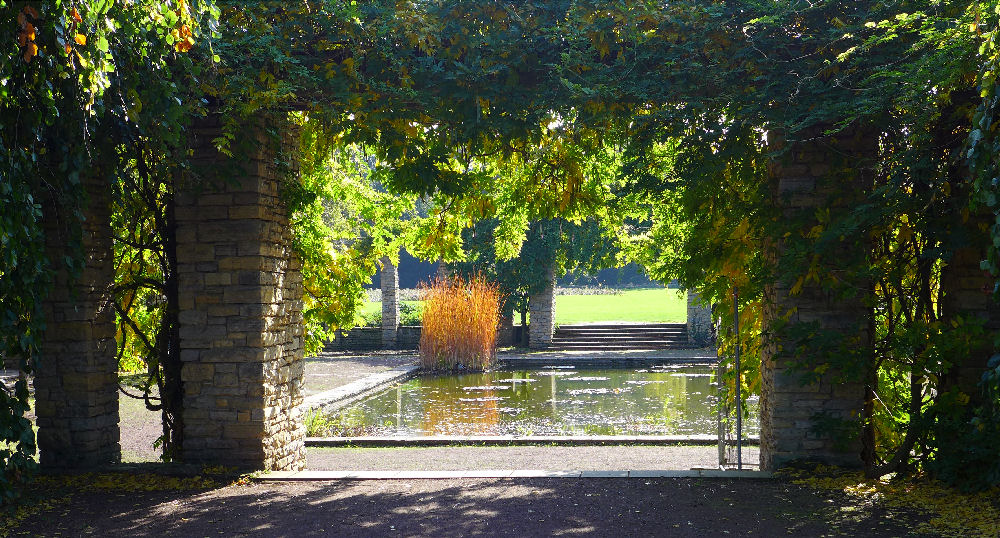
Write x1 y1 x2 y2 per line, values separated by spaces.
306 435 760 448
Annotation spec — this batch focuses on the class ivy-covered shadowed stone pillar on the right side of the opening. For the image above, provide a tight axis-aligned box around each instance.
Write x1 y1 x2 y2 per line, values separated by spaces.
760 129 874 470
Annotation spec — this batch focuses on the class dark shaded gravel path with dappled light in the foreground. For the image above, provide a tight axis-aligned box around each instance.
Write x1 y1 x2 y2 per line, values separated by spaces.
11 478 926 538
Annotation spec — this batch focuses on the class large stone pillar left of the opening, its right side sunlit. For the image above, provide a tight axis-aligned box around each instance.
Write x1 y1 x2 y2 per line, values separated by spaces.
176 117 305 470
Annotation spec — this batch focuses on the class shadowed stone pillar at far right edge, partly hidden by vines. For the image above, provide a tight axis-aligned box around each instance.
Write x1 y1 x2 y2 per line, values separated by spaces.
939 247 1000 398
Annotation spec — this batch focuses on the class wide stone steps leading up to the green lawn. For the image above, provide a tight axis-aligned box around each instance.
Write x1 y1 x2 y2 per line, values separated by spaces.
549 323 690 351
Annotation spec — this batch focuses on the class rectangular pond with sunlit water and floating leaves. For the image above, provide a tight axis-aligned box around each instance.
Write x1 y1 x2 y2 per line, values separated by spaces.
309 364 759 437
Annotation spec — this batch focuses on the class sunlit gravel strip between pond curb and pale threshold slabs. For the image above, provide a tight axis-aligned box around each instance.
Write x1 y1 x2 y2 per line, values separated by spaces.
306 446 757 471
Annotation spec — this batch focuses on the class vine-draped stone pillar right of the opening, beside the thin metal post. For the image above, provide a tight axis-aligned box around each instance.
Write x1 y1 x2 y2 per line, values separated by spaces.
760 130 868 470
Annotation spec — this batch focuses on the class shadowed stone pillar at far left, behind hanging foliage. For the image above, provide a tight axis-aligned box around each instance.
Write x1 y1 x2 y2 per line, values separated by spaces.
34 178 121 468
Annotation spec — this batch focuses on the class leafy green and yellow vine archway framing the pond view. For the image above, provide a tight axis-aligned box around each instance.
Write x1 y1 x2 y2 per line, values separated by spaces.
0 0 1000 496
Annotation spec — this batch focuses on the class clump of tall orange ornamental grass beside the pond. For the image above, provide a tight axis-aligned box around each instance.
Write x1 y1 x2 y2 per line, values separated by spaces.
420 275 502 370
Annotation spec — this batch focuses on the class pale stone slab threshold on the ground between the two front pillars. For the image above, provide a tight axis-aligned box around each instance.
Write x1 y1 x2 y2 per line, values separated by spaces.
255 469 772 482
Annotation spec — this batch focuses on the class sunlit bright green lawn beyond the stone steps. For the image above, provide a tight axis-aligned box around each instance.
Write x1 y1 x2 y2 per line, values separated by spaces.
359 288 687 324
